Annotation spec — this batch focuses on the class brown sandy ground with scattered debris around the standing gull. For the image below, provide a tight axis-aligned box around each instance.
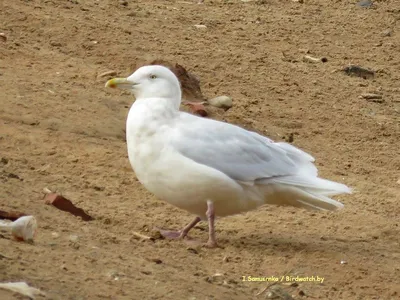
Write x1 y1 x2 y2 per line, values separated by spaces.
0 0 400 299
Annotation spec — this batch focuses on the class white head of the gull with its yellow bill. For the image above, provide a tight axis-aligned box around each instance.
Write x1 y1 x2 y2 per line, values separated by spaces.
106 65 181 107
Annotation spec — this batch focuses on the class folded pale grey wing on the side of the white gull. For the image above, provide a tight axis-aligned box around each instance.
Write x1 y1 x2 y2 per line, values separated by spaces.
171 114 312 182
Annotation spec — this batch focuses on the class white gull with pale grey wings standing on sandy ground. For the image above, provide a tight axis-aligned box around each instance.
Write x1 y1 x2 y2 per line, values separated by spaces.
105 65 351 248
